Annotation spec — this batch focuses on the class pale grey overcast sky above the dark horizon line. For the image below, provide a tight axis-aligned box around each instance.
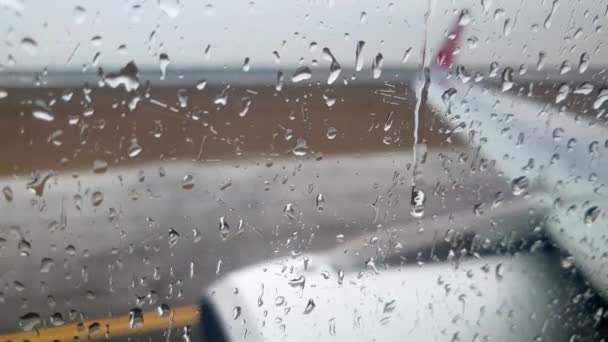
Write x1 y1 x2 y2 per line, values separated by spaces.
0 0 608 70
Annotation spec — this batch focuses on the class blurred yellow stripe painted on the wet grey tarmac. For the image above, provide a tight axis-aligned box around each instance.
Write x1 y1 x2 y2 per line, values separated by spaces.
0 305 199 342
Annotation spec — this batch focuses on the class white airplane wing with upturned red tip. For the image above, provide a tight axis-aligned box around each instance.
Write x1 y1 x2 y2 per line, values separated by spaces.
428 10 608 298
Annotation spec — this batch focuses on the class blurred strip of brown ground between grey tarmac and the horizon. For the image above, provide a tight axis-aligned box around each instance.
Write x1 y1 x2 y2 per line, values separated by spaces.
0 85 456 174
